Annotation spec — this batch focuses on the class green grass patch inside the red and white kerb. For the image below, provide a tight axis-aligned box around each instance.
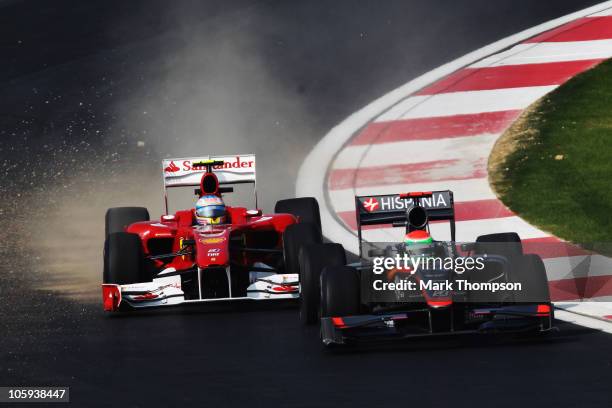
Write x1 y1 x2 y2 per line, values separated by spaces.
491 60 612 243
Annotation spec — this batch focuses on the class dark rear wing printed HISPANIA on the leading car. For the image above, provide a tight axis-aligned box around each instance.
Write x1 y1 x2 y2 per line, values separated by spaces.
355 190 455 253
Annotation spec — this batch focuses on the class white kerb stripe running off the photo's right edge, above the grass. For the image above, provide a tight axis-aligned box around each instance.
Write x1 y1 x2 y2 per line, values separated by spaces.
470 40 612 68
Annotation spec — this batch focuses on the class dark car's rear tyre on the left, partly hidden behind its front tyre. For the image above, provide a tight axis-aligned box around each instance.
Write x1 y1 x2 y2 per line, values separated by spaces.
298 244 346 325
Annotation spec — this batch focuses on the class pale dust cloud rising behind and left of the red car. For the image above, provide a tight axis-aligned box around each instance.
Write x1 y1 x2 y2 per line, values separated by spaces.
22 3 311 301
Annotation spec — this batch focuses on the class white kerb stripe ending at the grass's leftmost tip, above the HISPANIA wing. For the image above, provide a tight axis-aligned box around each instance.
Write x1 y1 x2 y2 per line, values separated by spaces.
332 134 500 170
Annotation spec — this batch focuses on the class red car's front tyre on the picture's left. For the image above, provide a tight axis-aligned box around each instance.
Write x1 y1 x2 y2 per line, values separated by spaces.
103 232 150 285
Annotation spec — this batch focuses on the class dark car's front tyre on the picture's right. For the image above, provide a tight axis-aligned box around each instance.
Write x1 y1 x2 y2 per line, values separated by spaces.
511 254 550 303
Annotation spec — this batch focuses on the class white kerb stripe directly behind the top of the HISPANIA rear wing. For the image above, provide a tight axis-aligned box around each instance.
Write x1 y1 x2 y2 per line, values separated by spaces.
329 178 496 212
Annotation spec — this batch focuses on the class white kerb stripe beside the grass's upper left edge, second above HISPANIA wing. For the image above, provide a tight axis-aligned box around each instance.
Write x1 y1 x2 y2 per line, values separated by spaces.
375 85 557 122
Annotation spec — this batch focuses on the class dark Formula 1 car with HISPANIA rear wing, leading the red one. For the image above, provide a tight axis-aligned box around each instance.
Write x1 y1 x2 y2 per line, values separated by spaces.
299 191 553 346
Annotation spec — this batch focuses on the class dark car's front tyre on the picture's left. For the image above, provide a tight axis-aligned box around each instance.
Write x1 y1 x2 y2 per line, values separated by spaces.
321 266 361 317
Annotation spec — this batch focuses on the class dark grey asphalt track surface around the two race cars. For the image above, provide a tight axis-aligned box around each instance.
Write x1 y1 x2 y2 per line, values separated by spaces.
0 0 612 407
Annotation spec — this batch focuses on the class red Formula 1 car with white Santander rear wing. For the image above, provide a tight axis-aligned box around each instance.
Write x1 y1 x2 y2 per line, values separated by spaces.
102 155 321 311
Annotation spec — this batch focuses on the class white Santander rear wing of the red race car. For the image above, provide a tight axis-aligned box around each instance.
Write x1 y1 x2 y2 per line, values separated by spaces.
162 154 257 214
